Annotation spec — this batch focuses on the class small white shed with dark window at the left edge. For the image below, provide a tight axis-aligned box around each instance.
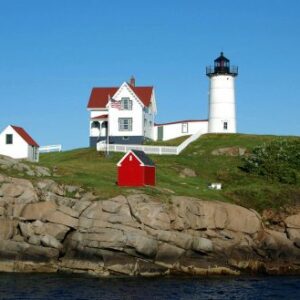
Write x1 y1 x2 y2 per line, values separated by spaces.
0 125 39 162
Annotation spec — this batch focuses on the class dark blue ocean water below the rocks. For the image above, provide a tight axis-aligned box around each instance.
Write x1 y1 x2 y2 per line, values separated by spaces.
0 273 300 300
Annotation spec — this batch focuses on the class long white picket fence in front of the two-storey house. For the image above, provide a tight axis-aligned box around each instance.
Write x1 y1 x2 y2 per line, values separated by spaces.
97 131 203 155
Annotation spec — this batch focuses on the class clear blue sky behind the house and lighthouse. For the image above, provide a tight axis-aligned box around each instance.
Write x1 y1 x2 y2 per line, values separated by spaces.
0 0 300 149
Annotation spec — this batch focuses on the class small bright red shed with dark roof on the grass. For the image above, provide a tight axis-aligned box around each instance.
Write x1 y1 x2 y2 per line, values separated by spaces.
117 150 155 186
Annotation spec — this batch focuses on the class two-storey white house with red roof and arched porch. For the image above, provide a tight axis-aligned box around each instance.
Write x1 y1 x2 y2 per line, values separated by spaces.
88 77 156 146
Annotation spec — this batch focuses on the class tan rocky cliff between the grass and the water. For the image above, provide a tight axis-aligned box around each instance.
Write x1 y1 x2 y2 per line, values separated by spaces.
0 166 300 276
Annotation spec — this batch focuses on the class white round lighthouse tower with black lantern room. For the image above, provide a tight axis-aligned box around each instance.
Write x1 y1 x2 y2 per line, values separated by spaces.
206 52 238 133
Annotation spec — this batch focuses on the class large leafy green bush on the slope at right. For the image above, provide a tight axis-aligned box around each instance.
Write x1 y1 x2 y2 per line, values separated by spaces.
242 139 300 184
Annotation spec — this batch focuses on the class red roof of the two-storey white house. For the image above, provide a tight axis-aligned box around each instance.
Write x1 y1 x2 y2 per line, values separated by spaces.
87 85 153 108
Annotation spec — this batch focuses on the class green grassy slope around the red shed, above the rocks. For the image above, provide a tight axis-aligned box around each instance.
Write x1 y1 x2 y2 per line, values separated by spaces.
40 134 300 210
